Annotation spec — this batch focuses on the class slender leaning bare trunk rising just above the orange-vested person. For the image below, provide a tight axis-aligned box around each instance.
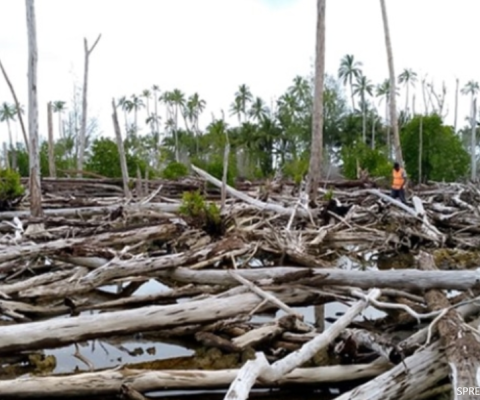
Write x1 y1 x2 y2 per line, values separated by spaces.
380 0 403 165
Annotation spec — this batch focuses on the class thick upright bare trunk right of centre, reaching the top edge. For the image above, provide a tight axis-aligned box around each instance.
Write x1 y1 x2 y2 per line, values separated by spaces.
307 0 326 201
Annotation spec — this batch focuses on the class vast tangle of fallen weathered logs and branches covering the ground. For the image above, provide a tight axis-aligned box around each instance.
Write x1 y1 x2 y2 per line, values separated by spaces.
0 167 480 400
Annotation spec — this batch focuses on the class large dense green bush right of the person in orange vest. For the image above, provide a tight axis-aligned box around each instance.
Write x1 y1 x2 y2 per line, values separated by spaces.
401 115 470 182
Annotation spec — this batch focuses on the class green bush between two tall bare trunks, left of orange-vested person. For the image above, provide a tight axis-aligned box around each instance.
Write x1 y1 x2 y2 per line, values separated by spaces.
342 141 392 179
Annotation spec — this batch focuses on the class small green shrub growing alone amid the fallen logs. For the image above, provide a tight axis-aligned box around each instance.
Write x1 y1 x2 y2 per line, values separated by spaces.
179 190 223 234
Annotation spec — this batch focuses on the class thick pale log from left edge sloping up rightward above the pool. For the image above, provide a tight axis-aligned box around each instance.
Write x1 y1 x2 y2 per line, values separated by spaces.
0 289 316 353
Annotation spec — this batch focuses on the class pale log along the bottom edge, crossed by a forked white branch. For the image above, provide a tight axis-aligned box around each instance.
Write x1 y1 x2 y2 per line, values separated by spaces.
0 362 388 399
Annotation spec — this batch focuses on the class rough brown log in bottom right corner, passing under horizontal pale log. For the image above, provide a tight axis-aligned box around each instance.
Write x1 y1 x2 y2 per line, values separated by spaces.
418 252 480 400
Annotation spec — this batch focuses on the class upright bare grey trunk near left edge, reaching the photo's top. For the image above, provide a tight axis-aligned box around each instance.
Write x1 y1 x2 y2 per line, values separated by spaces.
25 0 43 220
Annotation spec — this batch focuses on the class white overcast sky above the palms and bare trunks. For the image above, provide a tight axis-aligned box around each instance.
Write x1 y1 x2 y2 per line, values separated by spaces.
0 0 480 141
